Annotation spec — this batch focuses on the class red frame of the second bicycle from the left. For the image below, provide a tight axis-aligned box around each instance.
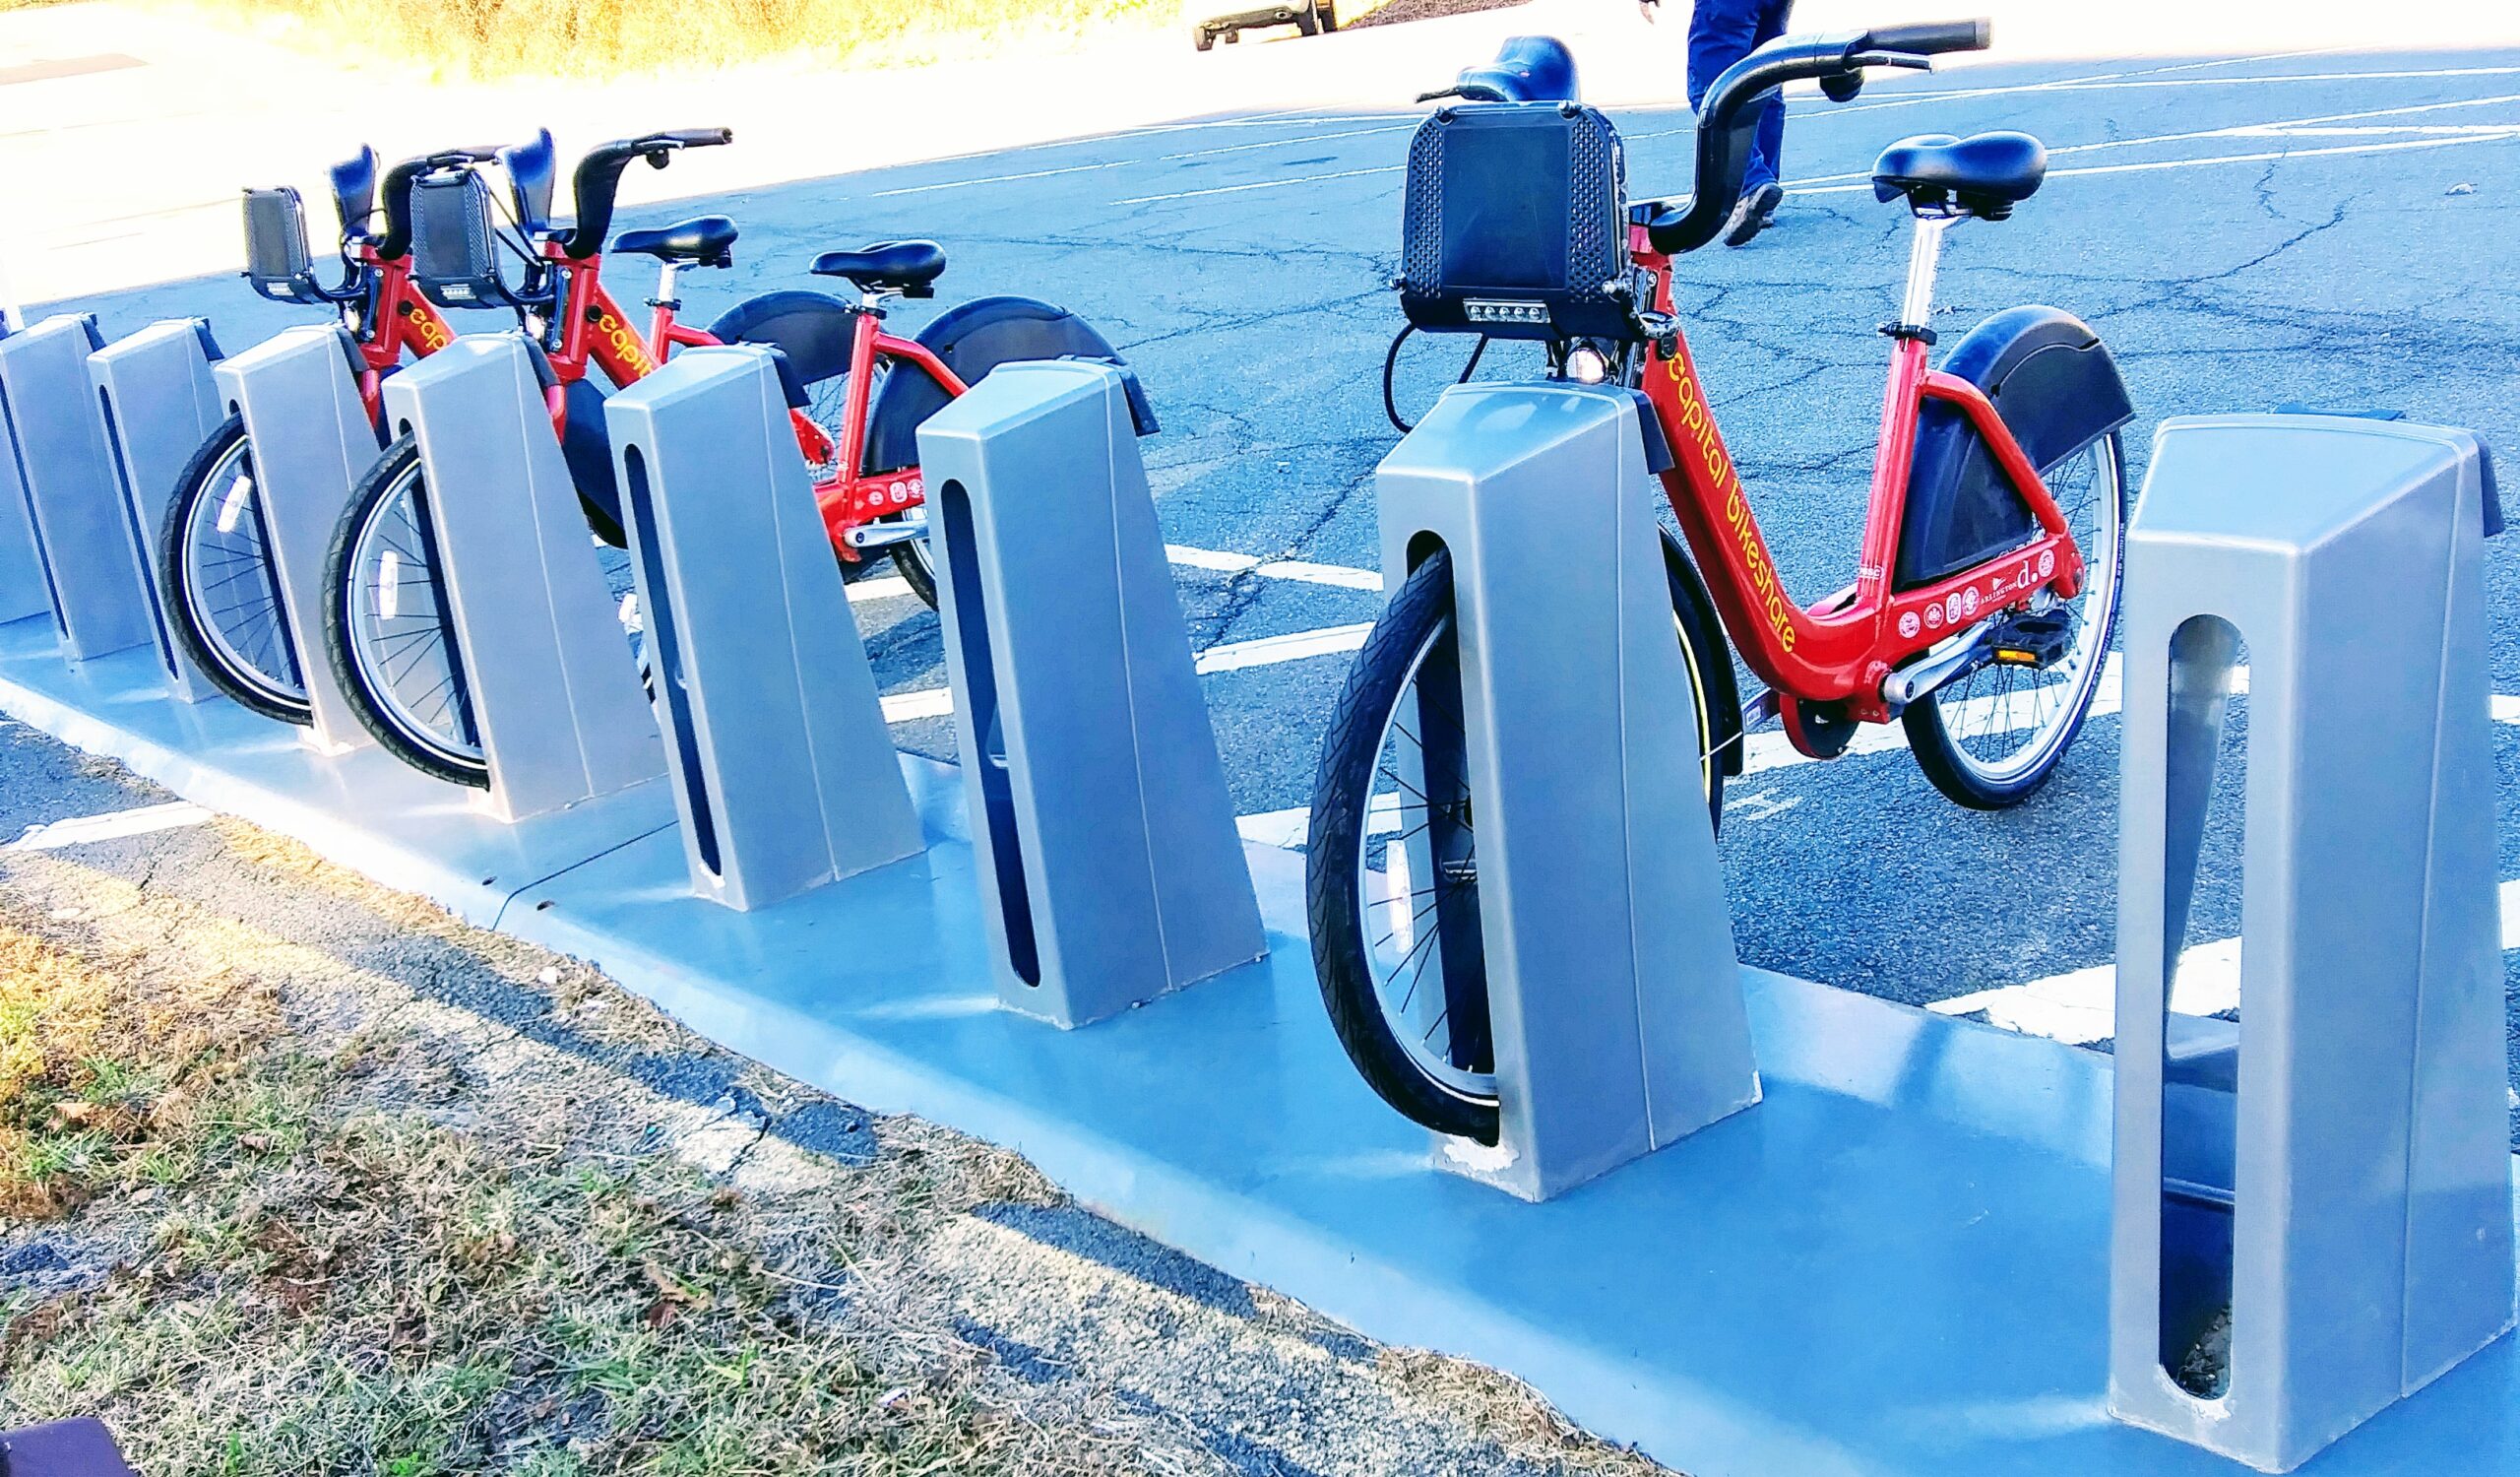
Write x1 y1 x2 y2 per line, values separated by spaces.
544 242 968 562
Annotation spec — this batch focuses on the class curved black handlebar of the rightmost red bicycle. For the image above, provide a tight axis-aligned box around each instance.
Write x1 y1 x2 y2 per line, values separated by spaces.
1628 20 1993 257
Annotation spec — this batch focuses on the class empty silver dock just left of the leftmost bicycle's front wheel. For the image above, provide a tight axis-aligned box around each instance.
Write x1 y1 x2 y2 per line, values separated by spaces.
89 318 226 703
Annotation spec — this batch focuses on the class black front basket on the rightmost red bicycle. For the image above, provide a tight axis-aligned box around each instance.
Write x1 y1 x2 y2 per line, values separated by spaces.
1401 103 1635 341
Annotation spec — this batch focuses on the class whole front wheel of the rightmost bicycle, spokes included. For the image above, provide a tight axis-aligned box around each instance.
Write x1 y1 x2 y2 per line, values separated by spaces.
1305 540 1732 1144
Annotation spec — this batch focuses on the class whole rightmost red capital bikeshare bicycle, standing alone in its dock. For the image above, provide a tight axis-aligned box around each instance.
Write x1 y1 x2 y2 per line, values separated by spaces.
1308 20 2132 1144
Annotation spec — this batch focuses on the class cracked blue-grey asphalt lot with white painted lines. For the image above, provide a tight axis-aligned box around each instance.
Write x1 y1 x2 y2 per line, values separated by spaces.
30 39 2520 1128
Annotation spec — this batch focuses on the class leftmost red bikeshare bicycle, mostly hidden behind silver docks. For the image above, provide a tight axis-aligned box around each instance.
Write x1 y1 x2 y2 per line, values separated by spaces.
158 149 475 724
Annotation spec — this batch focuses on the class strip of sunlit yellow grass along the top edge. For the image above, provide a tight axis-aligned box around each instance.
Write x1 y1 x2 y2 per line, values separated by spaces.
182 0 1179 76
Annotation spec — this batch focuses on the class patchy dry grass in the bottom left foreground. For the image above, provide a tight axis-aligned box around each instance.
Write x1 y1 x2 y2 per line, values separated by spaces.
0 907 1137 1477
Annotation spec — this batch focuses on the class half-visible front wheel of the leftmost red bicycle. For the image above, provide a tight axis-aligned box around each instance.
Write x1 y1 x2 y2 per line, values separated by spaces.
157 416 315 724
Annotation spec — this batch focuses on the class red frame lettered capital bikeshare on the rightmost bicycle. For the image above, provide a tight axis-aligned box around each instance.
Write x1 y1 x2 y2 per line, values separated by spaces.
1633 231 2084 724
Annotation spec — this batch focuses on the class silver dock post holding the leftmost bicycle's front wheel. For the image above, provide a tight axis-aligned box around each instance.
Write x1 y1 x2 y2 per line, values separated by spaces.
212 325 383 753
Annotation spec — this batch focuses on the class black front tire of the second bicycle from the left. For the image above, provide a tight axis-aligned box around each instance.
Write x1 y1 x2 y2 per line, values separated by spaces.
323 436 489 789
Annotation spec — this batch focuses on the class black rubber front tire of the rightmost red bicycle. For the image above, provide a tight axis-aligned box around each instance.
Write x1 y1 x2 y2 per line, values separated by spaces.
1305 532 1738 1144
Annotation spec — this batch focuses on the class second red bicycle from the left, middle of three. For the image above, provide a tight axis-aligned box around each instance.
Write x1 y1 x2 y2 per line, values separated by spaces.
299 129 1116 787
